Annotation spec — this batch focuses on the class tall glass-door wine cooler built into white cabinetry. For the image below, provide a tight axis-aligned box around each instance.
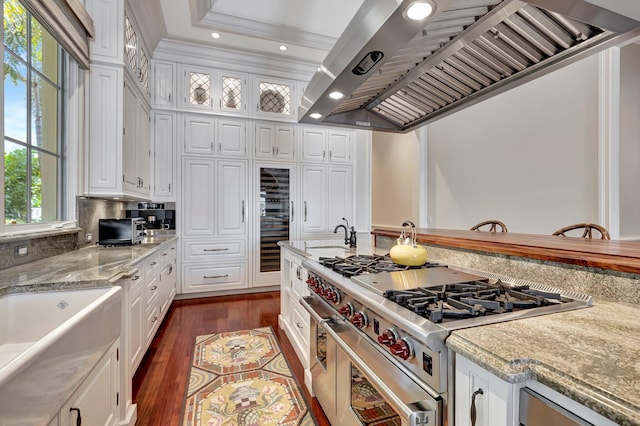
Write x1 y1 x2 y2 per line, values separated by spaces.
254 163 296 286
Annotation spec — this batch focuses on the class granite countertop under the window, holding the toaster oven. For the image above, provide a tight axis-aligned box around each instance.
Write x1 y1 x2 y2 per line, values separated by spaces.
0 235 177 296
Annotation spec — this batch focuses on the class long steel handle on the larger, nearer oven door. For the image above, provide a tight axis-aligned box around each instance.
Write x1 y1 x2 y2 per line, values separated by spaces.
322 322 440 426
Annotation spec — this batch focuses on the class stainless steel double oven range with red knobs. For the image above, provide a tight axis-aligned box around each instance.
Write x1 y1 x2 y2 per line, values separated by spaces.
300 255 592 426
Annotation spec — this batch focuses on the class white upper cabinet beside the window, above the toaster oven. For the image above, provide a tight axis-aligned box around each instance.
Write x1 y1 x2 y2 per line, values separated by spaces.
86 0 152 200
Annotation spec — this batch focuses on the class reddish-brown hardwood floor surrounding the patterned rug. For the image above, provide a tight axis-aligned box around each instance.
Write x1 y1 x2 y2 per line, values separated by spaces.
133 292 330 426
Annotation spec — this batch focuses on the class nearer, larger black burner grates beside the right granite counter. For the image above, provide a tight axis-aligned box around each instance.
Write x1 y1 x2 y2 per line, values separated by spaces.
384 280 565 323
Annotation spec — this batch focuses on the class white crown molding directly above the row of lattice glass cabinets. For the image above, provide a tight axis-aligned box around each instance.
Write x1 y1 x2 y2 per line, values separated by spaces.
153 40 318 81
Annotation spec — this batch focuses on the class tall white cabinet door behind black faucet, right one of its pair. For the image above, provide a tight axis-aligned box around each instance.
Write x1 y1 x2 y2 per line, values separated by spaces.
327 167 353 231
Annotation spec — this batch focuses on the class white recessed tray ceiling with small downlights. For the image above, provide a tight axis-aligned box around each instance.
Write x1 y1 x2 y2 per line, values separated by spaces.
129 0 364 64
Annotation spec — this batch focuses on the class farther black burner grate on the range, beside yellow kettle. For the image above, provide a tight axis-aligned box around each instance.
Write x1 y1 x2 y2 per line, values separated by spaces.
318 254 444 277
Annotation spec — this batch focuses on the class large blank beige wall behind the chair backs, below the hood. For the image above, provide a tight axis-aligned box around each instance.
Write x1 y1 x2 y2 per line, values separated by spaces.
427 56 598 234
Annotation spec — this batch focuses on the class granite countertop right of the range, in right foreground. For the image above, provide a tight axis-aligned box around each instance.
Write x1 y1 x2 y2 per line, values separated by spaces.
447 301 640 425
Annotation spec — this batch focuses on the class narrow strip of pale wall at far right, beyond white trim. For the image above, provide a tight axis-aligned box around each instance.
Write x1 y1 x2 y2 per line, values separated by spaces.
620 44 640 239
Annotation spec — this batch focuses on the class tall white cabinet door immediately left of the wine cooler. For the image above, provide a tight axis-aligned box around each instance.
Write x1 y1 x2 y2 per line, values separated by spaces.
217 161 247 235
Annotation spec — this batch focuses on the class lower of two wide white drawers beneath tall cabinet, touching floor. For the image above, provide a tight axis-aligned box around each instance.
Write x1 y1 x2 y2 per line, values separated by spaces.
182 264 248 293
